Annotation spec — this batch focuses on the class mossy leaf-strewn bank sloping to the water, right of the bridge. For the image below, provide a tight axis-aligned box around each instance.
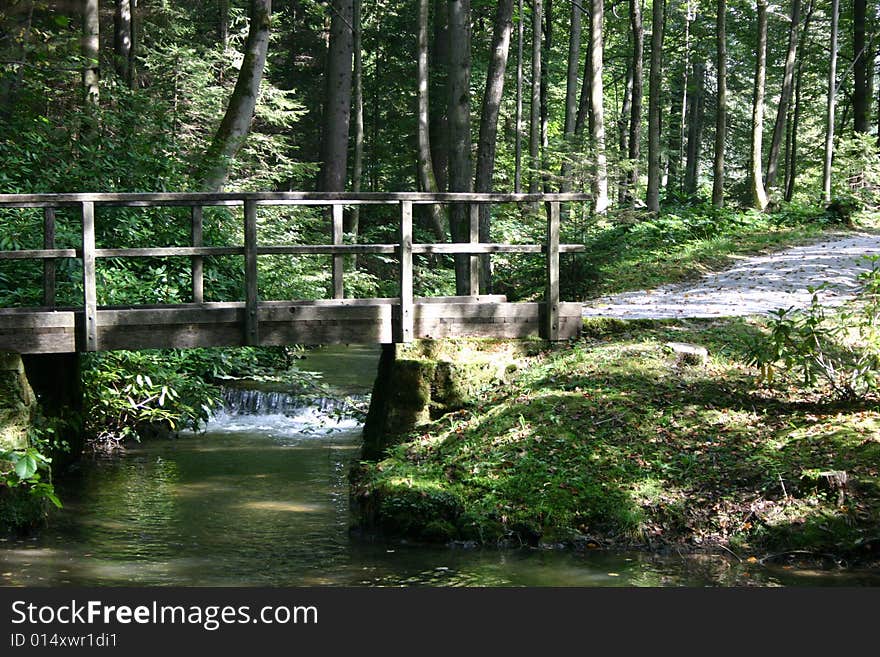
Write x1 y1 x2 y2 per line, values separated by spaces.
352 318 880 561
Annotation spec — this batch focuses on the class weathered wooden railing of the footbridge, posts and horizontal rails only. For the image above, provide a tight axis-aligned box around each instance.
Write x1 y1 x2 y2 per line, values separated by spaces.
0 192 589 351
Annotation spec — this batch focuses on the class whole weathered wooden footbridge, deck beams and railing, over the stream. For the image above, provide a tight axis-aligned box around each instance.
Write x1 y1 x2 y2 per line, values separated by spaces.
0 193 585 354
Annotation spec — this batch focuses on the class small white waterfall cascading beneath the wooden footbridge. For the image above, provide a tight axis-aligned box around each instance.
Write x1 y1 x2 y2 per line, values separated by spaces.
209 388 368 437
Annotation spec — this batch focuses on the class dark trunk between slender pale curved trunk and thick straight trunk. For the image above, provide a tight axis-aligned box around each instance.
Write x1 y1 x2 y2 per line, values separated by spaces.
428 0 449 191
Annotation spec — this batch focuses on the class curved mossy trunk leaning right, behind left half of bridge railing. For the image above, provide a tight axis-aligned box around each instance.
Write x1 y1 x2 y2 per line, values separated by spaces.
201 0 272 191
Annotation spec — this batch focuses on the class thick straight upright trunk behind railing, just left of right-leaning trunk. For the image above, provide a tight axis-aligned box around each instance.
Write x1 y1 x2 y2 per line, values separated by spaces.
448 0 470 295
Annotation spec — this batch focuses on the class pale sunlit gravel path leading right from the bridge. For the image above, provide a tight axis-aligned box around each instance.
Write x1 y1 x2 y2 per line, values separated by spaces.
584 233 880 319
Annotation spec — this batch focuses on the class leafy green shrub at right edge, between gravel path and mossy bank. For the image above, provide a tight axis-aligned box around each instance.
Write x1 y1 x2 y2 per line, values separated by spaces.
751 256 880 401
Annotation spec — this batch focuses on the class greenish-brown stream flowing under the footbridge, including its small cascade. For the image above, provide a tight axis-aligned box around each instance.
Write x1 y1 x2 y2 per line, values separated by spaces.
0 348 880 586
